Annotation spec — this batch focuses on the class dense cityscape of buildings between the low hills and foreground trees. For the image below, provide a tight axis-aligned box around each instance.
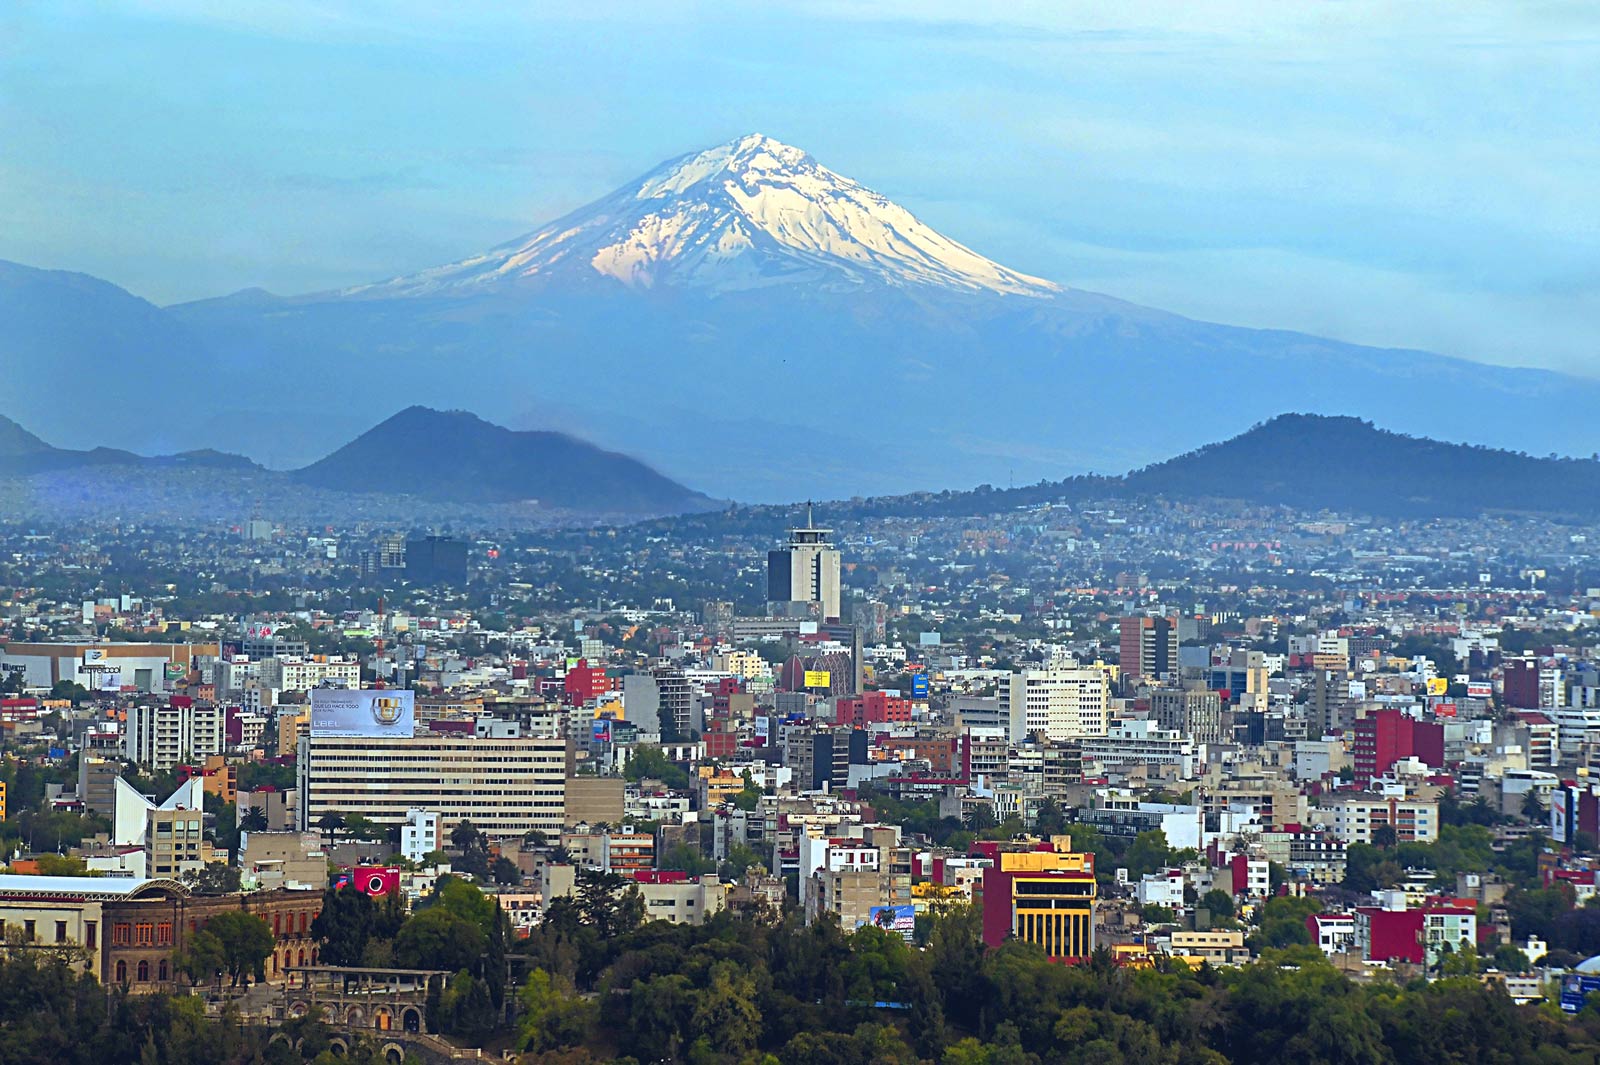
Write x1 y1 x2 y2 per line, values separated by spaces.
0 486 1600 1060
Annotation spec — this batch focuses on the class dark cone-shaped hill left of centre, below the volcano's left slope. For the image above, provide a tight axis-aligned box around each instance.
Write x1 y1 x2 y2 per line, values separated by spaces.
293 406 715 513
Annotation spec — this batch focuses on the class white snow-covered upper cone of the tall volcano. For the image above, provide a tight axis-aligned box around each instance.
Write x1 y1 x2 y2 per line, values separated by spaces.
342 134 1059 297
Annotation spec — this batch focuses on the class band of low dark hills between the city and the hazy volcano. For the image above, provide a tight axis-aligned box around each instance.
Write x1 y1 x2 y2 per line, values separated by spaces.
0 406 1600 521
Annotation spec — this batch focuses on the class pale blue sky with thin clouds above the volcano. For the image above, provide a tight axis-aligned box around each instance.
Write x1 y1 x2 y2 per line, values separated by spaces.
0 0 1600 372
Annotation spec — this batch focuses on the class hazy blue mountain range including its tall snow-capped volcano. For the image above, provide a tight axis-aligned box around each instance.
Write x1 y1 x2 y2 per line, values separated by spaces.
0 136 1600 501
